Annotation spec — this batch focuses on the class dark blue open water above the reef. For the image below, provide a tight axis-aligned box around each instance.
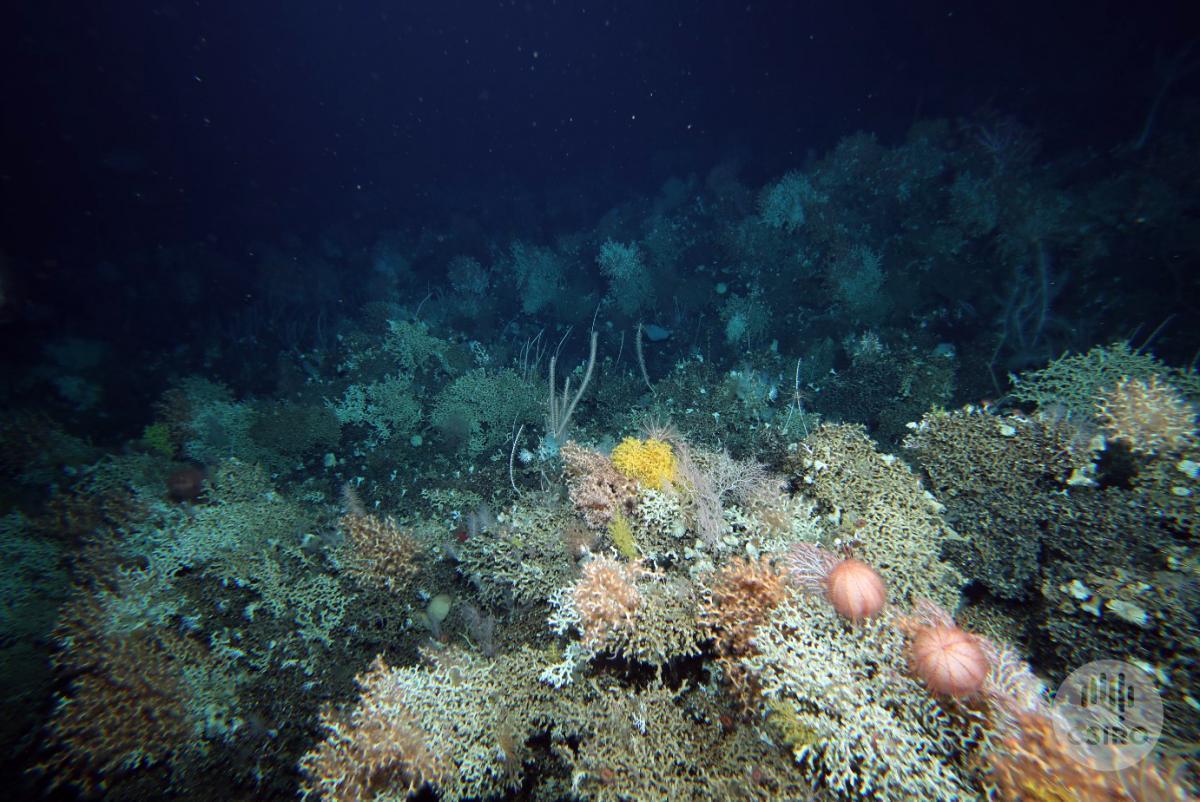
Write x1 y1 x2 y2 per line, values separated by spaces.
0 1 1196 381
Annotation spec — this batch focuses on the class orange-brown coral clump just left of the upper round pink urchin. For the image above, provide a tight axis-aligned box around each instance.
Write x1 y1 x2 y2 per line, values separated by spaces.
701 557 787 704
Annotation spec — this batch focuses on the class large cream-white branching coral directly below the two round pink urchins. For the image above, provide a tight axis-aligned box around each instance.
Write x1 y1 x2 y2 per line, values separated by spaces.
743 589 978 802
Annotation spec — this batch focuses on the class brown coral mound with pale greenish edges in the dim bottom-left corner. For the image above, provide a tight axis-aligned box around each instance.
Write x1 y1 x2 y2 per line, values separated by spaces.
38 569 244 796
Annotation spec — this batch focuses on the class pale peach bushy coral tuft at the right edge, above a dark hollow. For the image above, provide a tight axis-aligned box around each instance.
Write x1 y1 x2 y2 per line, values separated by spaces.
1096 375 1196 455
